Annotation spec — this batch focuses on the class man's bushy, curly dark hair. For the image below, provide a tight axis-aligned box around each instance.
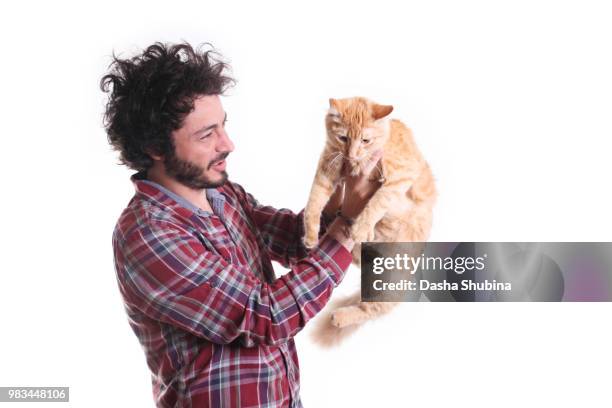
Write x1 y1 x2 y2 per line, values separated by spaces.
100 42 235 171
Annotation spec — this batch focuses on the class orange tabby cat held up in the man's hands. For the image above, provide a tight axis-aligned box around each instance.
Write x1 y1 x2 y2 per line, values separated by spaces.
304 97 436 345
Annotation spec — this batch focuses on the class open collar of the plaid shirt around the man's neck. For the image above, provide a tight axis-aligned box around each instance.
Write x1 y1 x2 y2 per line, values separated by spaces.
130 172 225 216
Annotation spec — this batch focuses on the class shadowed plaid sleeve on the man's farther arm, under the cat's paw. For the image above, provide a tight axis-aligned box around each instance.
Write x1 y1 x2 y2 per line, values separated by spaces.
227 183 334 268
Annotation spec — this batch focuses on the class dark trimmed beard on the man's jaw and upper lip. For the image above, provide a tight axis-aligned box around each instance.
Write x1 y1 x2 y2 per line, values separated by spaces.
164 149 229 190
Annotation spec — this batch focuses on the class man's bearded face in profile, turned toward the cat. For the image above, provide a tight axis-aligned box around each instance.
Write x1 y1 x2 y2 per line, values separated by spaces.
164 95 234 189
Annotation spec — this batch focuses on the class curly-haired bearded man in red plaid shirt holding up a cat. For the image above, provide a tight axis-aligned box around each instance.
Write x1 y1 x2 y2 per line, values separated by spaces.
101 43 378 407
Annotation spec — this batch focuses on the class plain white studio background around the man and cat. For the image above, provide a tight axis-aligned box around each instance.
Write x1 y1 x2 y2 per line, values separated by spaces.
0 0 612 408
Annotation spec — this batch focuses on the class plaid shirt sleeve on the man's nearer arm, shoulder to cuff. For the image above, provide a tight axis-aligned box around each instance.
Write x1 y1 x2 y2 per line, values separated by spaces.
114 221 351 347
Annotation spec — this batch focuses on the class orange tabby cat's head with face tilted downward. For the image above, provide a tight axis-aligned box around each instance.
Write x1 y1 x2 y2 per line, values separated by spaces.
325 97 393 174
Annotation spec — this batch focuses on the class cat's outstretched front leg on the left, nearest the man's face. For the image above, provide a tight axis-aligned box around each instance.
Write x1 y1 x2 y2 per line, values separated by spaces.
303 171 335 248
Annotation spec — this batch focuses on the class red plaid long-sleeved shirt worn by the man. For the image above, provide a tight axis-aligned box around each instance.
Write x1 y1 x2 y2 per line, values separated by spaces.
113 174 351 407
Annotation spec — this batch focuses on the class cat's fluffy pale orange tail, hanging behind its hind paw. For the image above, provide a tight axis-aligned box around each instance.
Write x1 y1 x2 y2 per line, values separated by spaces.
311 292 362 347
